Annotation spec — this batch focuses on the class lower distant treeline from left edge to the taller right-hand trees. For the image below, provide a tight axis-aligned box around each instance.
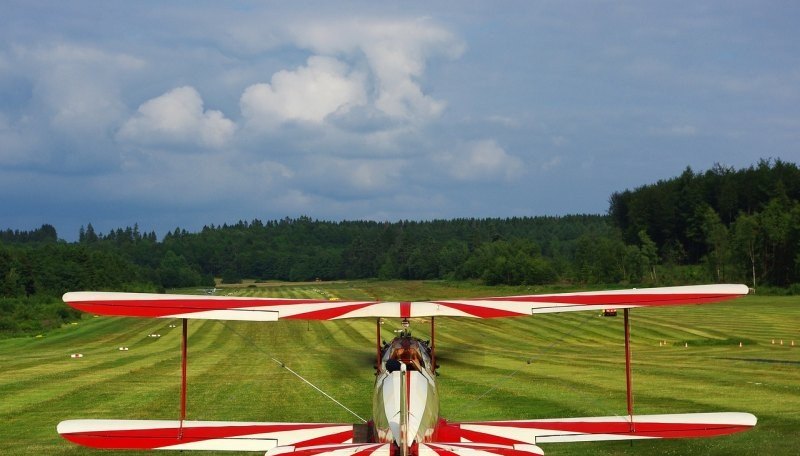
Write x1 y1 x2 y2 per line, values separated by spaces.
0 215 614 297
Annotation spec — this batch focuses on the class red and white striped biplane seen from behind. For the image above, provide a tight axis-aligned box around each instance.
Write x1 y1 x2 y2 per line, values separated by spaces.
58 285 756 456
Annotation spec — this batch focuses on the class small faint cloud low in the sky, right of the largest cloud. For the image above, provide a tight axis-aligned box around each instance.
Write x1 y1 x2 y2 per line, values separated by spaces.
439 139 523 181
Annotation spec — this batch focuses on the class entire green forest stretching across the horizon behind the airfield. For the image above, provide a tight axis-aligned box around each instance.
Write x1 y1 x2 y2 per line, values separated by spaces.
0 160 800 333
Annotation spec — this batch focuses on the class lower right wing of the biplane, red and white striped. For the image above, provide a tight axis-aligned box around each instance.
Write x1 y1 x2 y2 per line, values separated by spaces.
440 413 757 445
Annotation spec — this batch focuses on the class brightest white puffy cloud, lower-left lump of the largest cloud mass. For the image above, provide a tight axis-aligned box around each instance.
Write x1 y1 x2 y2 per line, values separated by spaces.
239 56 367 125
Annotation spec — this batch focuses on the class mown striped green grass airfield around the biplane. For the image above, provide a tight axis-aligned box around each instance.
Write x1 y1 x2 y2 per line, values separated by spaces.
0 281 800 456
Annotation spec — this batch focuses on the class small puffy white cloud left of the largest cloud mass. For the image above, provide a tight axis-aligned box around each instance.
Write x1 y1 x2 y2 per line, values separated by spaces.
118 86 236 147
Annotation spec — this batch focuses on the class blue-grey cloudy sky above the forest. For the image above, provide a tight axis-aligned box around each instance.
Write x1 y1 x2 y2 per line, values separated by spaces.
0 0 800 240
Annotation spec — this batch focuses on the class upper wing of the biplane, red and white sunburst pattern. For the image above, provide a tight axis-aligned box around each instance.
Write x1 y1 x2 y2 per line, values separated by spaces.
63 285 748 321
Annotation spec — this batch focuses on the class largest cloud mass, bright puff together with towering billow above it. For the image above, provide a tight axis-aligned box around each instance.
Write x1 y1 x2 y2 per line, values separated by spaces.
234 18 464 134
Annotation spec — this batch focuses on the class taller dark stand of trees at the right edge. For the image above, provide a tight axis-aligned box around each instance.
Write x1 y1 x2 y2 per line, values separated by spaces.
609 160 800 287
